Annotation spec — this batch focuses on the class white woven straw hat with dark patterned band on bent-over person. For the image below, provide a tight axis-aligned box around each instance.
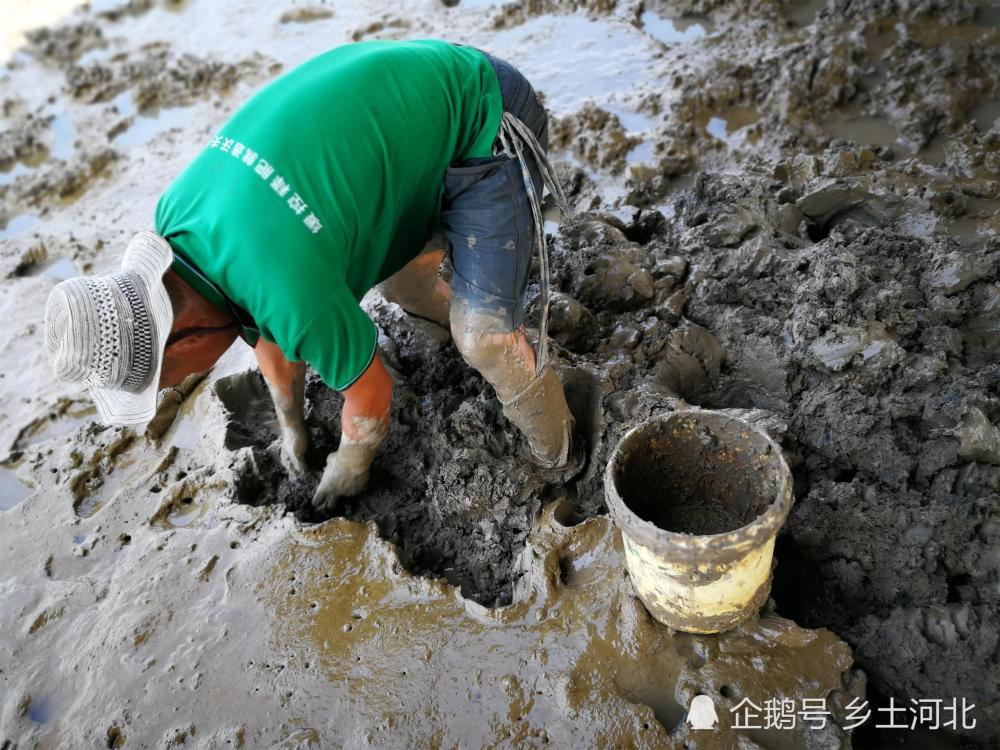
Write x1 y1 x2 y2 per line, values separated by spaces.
45 232 174 424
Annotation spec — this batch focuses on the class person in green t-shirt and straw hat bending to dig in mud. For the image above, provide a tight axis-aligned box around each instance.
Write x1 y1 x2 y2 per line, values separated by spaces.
46 41 573 510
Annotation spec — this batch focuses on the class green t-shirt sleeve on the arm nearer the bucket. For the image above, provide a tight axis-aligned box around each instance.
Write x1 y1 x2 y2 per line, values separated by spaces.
297 285 378 391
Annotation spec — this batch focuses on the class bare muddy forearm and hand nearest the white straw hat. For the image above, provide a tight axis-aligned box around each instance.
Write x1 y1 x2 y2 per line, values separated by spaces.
254 339 309 475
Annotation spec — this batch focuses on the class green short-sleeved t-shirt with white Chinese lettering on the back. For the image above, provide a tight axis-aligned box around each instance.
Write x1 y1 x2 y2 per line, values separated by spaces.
156 41 503 390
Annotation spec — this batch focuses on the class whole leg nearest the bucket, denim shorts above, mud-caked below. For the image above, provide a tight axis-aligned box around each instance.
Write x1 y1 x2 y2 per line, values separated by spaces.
442 51 573 468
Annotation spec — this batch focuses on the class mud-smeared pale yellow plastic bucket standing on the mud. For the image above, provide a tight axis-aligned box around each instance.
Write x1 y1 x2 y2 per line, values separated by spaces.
604 409 792 633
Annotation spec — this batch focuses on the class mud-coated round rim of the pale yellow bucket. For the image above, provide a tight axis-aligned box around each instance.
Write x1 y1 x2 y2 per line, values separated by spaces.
604 408 793 553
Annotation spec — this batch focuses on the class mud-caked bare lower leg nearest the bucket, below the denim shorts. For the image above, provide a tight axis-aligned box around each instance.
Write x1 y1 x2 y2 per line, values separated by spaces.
451 301 573 469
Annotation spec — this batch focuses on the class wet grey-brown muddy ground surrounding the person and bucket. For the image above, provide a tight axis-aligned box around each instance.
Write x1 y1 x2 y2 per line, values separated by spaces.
0 0 1000 748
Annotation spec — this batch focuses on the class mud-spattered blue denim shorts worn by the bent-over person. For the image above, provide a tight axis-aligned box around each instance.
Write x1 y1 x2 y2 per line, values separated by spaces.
440 52 549 333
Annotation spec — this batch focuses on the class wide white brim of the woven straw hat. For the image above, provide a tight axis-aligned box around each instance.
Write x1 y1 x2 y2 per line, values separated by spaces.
90 232 174 425
